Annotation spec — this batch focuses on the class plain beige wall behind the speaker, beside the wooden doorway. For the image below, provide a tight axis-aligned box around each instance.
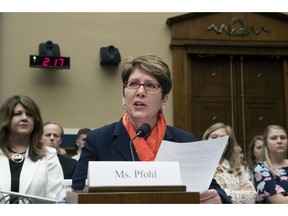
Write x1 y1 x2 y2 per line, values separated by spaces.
0 13 181 132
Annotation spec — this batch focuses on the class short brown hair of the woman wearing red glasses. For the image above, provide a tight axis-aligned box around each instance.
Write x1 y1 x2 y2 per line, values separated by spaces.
121 54 172 96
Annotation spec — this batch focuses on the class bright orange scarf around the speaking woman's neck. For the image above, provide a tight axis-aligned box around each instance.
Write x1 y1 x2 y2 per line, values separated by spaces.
122 113 166 161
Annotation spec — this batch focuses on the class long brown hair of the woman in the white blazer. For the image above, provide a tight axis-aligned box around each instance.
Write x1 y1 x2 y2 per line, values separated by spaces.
0 95 46 161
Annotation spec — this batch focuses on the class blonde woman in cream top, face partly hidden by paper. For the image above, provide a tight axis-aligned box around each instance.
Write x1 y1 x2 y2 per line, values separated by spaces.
202 123 256 203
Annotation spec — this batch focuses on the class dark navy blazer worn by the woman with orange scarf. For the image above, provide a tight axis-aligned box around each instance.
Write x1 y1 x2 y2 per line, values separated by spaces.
72 119 231 203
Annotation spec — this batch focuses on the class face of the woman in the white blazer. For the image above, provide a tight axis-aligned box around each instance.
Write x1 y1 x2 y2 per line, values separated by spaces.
10 104 34 138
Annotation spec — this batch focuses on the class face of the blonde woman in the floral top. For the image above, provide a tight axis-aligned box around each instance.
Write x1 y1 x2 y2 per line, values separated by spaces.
267 129 287 154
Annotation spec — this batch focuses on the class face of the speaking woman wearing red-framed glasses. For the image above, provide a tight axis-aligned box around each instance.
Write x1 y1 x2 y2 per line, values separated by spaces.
123 69 168 127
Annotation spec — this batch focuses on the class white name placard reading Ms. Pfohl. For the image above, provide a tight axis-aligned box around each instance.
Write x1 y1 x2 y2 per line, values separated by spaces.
87 161 182 187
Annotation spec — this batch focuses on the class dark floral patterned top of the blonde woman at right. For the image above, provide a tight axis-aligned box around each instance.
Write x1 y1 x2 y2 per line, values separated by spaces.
253 162 288 203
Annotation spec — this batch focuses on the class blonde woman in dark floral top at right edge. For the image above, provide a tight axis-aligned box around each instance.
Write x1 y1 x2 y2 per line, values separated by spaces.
253 125 288 203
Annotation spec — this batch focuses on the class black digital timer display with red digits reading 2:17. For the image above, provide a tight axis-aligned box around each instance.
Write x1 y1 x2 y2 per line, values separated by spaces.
30 55 70 69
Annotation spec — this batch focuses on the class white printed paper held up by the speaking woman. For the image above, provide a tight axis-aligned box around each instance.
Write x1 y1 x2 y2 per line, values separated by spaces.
155 136 229 193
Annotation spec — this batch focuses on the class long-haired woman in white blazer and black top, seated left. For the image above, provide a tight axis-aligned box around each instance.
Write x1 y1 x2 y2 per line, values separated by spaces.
0 95 63 203
